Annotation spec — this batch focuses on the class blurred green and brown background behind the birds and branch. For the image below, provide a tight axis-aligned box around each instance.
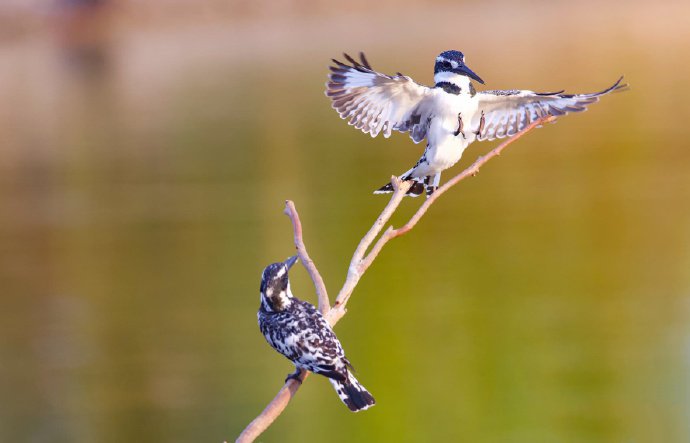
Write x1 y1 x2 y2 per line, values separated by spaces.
0 0 690 442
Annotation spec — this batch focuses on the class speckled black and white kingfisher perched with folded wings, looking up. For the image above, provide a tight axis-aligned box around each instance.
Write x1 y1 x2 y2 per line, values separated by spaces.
258 256 375 412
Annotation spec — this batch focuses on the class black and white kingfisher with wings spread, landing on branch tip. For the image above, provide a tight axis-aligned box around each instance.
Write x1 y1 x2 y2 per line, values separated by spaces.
326 51 627 196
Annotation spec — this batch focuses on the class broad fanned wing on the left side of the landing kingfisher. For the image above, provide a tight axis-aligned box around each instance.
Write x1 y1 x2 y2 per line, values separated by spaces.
326 53 432 143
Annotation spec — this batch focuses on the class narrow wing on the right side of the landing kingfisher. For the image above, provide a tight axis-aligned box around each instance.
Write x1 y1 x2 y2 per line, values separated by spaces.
471 77 628 141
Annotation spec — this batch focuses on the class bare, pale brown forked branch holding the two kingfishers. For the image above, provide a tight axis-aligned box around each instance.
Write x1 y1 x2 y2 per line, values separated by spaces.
236 117 556 443
